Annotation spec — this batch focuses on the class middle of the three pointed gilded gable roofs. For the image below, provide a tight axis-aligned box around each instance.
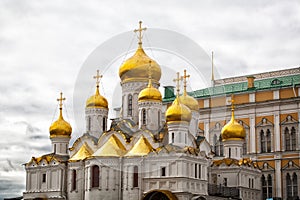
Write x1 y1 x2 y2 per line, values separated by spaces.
93 134 126 157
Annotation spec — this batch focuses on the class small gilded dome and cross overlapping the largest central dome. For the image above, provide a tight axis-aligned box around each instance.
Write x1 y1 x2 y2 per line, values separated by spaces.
138 62 162 102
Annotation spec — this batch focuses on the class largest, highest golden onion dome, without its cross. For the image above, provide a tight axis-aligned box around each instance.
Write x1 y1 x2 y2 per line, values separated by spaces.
119 45 161 83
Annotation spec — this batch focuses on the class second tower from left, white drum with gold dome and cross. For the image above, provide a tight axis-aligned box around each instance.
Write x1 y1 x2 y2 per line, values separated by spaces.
85 70 108 138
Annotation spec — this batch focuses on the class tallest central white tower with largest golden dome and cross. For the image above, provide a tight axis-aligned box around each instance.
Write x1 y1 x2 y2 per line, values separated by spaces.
119 21 161 124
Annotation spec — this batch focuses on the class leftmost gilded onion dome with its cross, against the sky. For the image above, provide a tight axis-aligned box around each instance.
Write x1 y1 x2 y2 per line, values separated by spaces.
49 93 72 138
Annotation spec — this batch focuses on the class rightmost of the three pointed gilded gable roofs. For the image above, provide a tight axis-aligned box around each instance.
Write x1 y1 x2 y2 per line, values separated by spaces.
125 135 155 157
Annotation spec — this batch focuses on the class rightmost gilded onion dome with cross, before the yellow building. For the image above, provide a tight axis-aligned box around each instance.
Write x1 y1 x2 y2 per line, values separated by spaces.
221 100 246 141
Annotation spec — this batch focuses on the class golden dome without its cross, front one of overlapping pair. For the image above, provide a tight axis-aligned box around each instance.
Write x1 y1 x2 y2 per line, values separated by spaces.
166 96 192 122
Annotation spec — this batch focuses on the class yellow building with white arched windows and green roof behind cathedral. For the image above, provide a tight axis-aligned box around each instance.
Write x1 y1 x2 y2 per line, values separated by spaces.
163 67 300 199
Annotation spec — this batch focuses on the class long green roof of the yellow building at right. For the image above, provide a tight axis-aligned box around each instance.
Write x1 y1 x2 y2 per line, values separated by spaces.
163 74 300 102
